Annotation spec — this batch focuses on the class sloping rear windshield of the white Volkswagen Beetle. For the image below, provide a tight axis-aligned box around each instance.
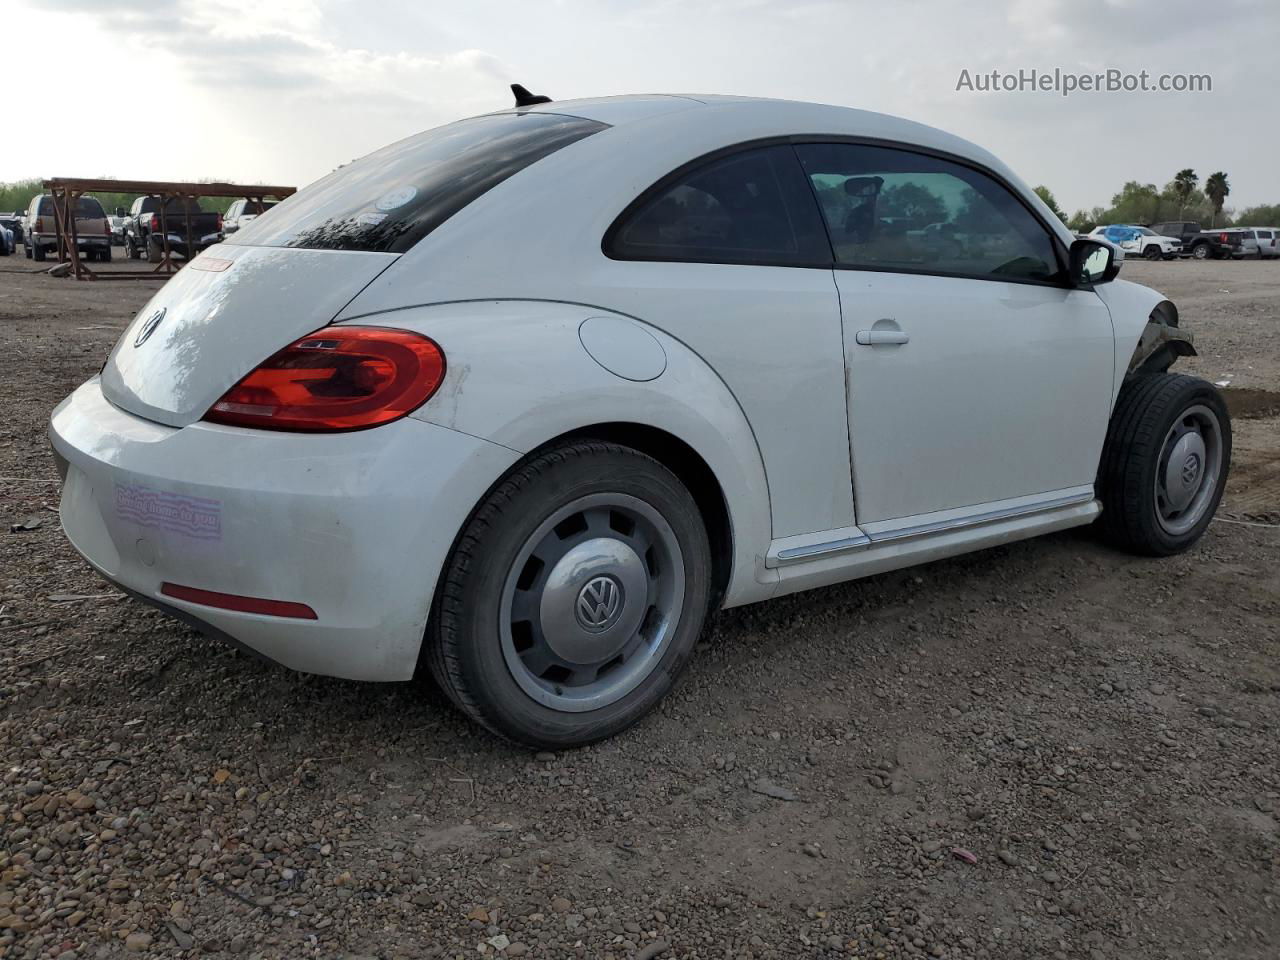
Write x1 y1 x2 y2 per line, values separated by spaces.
228 113 608 253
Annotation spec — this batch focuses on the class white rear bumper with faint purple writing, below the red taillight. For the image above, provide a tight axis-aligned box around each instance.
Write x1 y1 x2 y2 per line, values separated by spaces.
49 378 517 680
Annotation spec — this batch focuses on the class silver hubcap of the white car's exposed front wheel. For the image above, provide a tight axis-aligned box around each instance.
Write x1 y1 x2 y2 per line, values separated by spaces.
1156 404 1222 536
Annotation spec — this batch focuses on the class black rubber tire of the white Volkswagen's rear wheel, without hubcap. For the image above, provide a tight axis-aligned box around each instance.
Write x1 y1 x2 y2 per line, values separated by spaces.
425 442 712 749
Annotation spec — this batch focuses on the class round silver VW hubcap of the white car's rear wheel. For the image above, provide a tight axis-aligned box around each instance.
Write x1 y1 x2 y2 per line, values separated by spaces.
500 494 685 713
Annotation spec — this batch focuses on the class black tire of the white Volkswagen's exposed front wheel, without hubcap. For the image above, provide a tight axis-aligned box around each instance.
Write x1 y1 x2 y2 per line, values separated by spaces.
1097 374 1231 557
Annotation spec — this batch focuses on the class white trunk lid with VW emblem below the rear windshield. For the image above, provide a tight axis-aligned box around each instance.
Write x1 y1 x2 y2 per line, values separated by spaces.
102 244 398 426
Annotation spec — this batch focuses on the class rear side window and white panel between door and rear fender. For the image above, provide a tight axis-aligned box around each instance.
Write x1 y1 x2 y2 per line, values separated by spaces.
593 143 854 538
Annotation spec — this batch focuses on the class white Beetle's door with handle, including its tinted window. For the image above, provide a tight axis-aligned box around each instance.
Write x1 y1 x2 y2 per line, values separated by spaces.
796 143 1114 527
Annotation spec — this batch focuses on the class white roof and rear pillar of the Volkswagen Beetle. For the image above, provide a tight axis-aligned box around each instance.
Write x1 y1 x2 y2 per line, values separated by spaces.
343 93 1075 319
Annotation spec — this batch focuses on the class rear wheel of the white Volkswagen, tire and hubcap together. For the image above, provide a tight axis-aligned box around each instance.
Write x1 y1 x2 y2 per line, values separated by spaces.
426 442 712 749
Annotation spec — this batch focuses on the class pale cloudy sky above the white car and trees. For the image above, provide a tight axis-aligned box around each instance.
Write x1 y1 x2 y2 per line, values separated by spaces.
0 0 1280 211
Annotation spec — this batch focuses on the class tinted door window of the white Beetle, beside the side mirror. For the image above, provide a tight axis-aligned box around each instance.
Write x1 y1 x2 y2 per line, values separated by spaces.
796 143 1061 280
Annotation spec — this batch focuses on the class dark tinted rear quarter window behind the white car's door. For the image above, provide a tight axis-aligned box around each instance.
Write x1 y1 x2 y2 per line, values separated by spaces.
604 146 831 266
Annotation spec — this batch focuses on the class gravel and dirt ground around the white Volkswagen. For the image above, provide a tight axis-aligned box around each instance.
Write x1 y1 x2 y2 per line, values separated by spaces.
0 259 1280 960
